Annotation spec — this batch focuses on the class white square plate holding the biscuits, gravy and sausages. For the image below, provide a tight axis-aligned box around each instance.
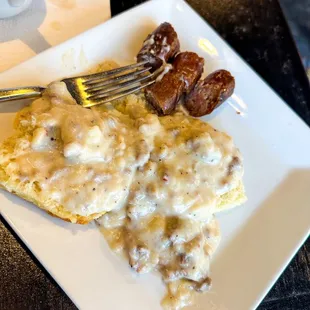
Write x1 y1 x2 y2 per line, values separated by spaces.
0 0 310 310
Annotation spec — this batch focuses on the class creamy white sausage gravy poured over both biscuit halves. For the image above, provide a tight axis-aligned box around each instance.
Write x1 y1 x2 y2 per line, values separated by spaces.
7 74 243 309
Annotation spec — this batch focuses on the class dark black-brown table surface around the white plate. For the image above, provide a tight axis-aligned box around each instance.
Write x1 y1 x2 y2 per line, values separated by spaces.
0 0 310 310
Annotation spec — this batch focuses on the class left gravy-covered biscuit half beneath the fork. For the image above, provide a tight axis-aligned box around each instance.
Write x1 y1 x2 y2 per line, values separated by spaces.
0 82 142 224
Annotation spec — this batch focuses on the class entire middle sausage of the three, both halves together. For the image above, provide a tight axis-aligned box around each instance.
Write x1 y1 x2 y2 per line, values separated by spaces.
145 52 204 115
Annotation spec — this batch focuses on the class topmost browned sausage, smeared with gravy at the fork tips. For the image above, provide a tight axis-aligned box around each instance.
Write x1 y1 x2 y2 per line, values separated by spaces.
137 23 180 71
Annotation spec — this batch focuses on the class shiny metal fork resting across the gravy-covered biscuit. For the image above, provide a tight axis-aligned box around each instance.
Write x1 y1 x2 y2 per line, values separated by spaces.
0 61 163 107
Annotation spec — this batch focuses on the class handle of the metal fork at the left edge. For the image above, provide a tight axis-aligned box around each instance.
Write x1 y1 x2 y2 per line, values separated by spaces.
0 86 45 103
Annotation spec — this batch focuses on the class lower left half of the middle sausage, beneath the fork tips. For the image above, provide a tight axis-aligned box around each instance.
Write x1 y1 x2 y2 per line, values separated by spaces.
145 70 184 115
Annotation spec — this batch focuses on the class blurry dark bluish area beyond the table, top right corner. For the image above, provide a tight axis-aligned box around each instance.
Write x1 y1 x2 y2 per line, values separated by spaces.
279 0 310 80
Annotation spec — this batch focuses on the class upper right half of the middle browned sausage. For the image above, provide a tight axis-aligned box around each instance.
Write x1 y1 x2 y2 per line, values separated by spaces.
173 52 204 94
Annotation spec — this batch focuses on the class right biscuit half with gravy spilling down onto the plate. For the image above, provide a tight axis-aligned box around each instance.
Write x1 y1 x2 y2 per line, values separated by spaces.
98 97 245 309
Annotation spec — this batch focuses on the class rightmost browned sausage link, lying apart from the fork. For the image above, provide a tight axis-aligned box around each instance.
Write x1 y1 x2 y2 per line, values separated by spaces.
184 70 235 116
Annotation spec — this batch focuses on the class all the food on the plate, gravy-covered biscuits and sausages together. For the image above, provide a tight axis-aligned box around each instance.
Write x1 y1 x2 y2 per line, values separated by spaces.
0 23 246 310
